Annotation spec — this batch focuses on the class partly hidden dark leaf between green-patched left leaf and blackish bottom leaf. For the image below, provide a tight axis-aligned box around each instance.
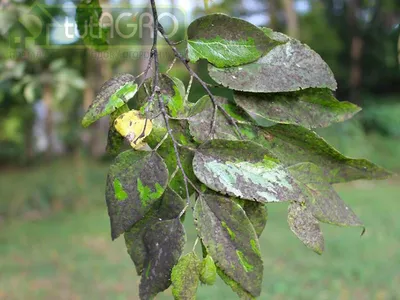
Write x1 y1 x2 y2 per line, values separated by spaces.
124 187 186 275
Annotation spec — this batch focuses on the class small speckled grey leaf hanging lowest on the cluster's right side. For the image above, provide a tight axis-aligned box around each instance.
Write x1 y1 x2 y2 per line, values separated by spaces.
288 201 324 254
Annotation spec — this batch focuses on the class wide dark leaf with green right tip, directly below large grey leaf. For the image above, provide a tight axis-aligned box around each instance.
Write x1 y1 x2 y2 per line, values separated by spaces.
235 89 361 128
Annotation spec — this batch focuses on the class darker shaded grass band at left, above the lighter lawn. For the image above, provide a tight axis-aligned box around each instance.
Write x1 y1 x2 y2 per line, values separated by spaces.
0 157 108 221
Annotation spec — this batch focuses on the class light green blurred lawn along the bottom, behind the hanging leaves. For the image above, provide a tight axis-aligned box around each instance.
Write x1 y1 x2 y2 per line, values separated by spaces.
0 181 400 300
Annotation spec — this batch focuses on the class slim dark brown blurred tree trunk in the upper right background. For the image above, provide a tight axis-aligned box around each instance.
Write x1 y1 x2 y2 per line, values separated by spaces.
347 0 364 105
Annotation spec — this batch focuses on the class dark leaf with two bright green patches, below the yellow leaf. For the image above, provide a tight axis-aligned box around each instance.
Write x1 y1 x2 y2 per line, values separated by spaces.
106 150 168 239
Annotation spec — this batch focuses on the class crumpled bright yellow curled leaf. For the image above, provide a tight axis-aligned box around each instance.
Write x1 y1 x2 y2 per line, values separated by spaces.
114 110 153 150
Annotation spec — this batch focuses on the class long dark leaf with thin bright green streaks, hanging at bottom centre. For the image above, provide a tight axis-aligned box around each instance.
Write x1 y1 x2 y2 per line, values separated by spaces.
193 193 263 297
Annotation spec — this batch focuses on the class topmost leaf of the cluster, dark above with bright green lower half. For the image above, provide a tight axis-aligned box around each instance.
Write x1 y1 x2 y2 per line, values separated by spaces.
187 14 275 68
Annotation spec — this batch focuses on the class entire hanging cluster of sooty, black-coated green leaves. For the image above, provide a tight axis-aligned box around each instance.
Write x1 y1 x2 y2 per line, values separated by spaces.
83 14 390 299
